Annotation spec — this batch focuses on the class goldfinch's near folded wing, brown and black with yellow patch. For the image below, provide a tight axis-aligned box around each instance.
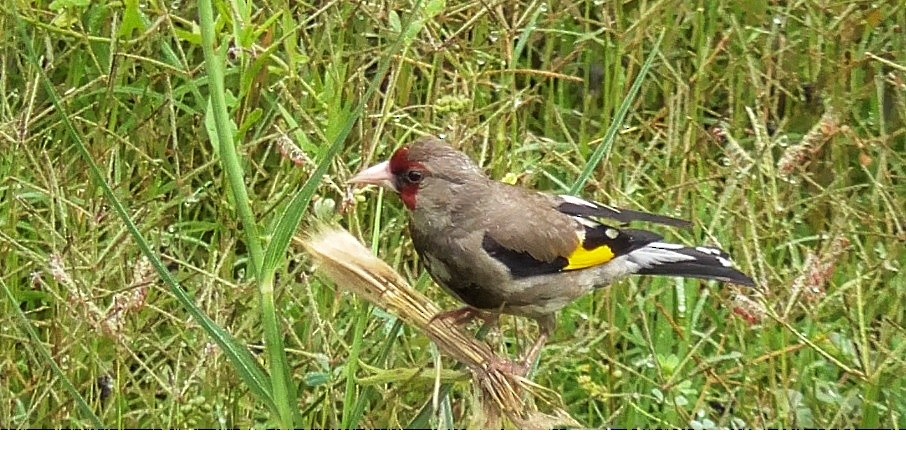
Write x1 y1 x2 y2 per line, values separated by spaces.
482 188 663 278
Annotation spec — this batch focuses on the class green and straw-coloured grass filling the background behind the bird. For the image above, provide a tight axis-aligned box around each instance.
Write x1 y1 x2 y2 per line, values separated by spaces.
0 0 906 428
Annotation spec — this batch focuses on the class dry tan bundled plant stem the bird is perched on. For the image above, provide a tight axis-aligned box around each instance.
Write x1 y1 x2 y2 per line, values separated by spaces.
304 228 575 428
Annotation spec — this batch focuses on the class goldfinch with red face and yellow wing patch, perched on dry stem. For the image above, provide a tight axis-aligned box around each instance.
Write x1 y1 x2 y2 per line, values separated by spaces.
348 137 756 376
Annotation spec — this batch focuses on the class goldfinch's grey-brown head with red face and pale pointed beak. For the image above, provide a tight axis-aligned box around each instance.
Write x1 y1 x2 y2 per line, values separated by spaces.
349 138 486 211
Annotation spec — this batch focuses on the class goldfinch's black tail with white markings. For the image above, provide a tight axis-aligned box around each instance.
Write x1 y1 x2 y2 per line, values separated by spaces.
629 242 755 287
